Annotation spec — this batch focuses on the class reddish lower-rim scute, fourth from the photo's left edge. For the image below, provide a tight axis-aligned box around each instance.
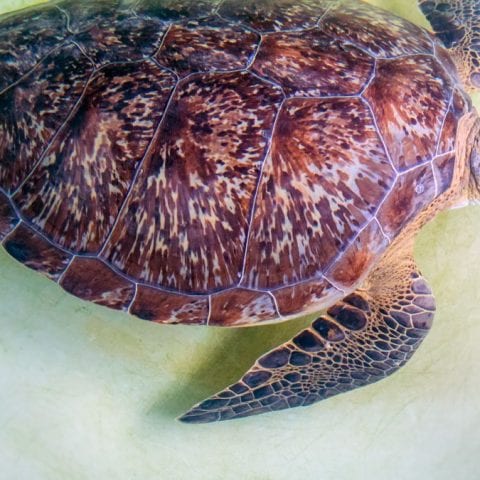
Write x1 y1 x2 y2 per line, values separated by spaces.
130 285 208 325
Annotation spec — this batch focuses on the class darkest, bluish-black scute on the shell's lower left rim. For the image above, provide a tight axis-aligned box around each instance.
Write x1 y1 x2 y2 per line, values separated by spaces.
3 223 71 280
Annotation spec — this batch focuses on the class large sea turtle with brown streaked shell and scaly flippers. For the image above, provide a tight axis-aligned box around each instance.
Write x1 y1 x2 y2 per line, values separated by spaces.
0 0 480 422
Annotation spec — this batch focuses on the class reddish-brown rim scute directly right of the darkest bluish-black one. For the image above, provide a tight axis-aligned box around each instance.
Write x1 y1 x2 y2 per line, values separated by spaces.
60 257 135 310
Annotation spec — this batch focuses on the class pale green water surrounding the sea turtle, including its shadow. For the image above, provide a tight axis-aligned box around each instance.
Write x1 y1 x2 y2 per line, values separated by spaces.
0 0 480 480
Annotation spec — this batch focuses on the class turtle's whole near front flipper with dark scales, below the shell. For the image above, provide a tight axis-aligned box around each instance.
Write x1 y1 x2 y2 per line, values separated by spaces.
180 248 435 423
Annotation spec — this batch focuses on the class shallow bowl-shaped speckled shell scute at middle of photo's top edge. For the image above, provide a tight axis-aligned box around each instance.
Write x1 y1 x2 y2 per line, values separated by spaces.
218 0 332 33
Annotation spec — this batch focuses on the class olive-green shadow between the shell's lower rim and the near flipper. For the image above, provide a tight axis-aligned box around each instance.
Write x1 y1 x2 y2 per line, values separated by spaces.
147 314 318 419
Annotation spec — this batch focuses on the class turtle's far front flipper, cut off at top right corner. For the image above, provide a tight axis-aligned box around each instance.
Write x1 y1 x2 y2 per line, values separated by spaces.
418 0 480 89
